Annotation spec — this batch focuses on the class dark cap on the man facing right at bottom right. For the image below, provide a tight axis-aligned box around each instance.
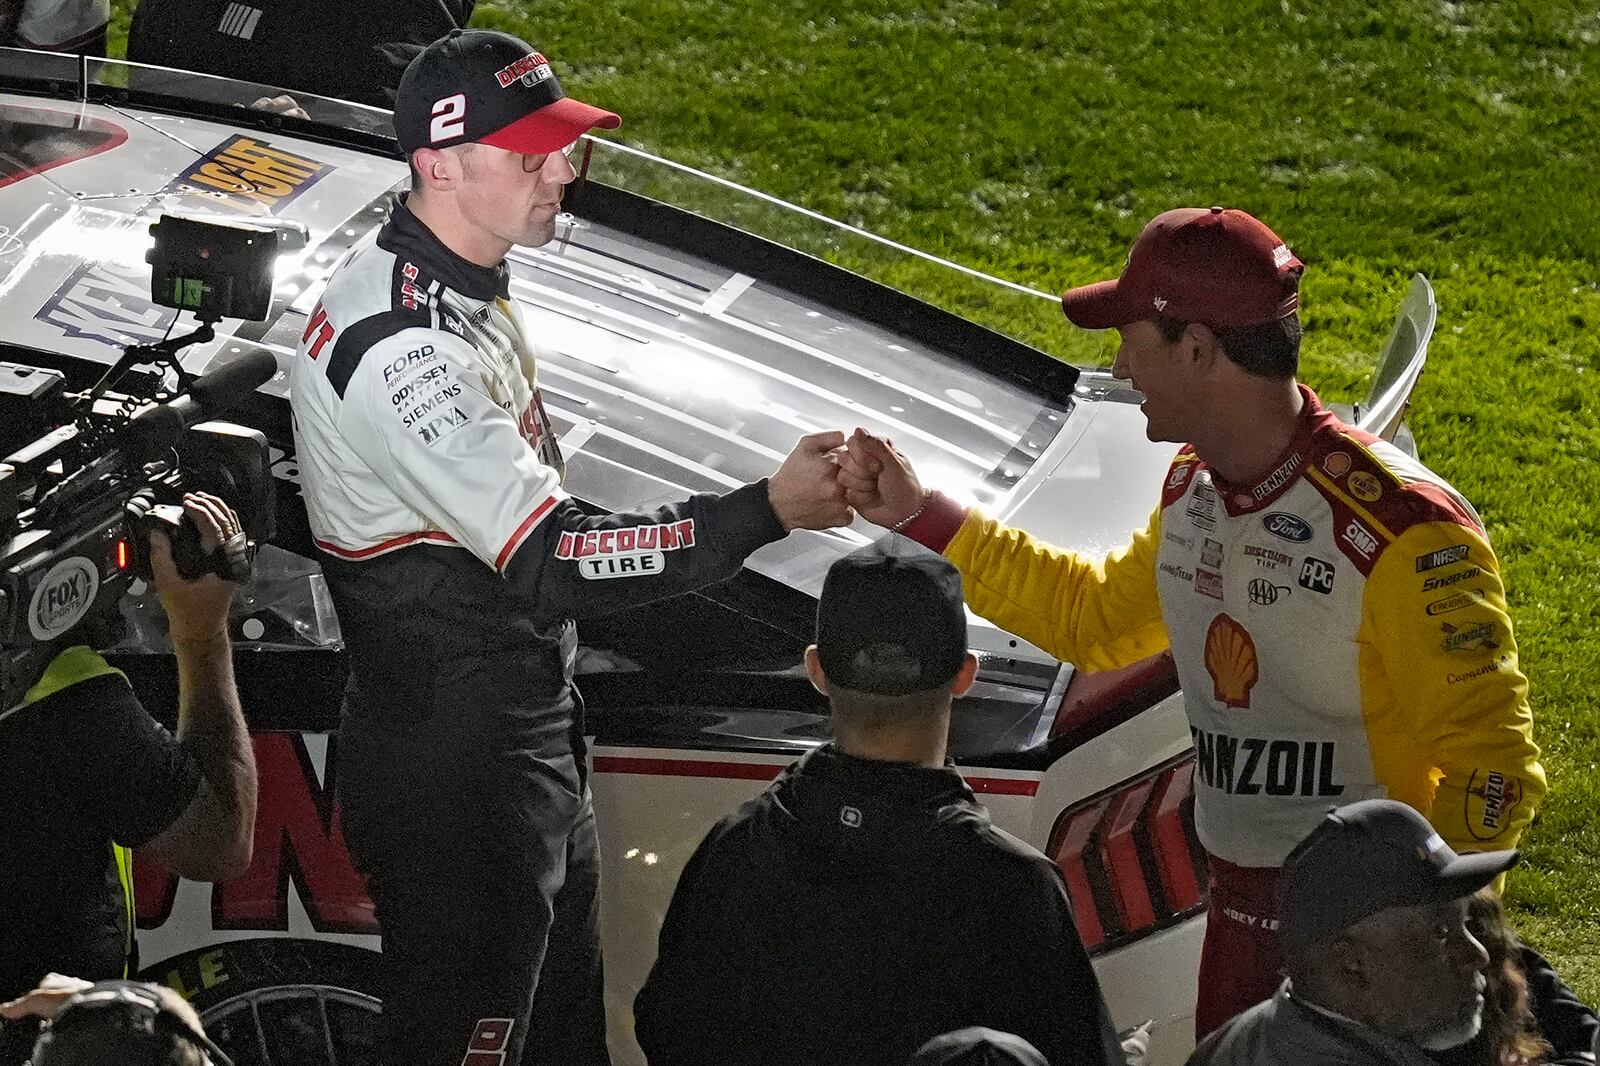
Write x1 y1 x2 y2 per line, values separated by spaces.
1278 800 1522 946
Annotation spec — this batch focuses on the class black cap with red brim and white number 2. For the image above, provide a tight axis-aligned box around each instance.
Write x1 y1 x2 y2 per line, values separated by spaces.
395 29 622 157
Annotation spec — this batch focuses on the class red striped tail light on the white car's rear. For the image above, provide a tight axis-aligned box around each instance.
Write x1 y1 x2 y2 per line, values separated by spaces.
1048 752 1206 954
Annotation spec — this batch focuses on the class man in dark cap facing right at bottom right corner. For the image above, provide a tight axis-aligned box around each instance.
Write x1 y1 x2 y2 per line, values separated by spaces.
1189 800 1518 1066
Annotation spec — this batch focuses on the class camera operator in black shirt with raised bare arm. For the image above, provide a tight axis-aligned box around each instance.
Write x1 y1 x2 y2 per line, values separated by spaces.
0 493 256 1066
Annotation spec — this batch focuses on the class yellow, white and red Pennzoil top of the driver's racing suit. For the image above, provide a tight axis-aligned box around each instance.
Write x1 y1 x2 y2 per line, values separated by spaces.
906 389 1546 1021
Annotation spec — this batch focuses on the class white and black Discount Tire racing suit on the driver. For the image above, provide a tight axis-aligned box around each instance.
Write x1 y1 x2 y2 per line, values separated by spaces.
291 200 784 1066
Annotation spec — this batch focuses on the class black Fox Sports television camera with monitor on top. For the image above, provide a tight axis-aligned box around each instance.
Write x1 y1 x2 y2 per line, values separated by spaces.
0 214 278 711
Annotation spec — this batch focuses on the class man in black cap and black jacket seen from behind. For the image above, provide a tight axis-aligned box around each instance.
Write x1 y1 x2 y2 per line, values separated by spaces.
634 538 1122 1066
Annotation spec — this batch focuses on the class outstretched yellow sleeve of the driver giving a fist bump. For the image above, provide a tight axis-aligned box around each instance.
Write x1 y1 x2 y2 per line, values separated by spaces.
944 509 1168 672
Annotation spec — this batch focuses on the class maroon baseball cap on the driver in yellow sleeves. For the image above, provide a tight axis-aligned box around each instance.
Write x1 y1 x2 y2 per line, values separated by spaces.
1061 208 1306 330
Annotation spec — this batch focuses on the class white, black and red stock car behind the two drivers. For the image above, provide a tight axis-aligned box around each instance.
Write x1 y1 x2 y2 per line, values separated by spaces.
0 50 1434 1066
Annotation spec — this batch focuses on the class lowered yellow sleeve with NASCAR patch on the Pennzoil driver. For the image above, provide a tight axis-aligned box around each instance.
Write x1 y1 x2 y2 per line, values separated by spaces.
1358 522 1546 852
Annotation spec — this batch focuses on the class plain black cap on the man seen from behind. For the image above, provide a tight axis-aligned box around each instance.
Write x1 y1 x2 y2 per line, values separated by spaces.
816 535 966 696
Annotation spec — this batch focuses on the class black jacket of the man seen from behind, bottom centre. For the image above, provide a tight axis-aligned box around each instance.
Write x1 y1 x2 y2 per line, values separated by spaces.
634 746 1122 1066
